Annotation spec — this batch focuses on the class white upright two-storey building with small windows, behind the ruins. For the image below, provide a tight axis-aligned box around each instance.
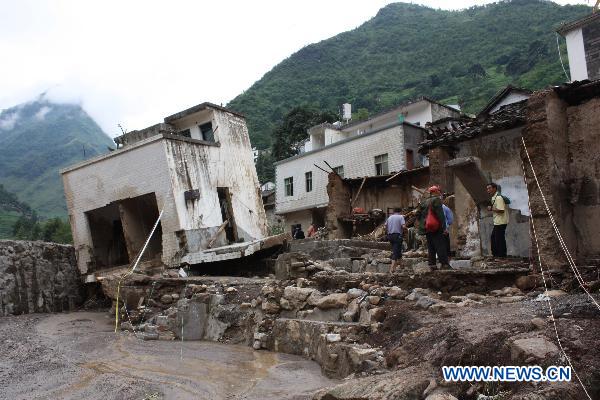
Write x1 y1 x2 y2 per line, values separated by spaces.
275 98 460 232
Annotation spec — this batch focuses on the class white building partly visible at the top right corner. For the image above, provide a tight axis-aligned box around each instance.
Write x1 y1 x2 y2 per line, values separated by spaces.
558 12 600 81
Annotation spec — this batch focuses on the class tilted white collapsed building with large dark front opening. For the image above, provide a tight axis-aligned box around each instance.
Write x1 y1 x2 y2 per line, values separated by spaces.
62 103 267 273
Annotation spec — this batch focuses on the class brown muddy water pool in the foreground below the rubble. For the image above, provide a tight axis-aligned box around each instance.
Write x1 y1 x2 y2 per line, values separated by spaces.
8 313 337 400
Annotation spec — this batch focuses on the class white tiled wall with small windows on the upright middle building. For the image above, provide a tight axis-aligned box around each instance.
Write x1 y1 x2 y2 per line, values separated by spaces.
275 125 405 213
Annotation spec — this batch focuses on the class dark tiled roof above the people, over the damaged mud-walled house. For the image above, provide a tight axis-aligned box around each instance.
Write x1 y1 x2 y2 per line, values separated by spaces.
419 100 527 151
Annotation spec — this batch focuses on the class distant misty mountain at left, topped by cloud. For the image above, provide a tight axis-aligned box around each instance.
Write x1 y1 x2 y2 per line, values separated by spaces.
0 96 114 231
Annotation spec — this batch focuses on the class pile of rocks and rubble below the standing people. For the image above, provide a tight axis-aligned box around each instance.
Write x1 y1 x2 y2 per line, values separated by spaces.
103 240 600 400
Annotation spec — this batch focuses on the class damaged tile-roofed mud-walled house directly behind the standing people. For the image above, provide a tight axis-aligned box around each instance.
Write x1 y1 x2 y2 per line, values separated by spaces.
420 86 531 257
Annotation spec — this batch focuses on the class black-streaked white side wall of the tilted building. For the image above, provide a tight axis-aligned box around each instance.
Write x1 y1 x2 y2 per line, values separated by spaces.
166 110 267 241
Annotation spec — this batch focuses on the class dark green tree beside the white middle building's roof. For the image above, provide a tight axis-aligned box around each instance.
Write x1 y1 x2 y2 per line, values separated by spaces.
271 106 338 161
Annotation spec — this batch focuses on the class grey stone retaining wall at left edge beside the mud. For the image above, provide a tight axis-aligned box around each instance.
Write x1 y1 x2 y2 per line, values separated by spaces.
0 240 83 315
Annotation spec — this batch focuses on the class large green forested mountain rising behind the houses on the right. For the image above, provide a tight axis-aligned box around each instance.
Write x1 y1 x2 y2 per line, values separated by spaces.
228 0 591 148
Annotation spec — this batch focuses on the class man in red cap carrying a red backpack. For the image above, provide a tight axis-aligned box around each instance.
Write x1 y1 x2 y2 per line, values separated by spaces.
417 186 450 269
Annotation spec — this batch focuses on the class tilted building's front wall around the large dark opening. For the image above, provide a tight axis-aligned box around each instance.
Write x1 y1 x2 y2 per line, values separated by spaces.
63 136 180 274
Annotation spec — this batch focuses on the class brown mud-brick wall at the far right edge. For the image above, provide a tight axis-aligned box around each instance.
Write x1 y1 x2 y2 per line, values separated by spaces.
522 81 600 267
